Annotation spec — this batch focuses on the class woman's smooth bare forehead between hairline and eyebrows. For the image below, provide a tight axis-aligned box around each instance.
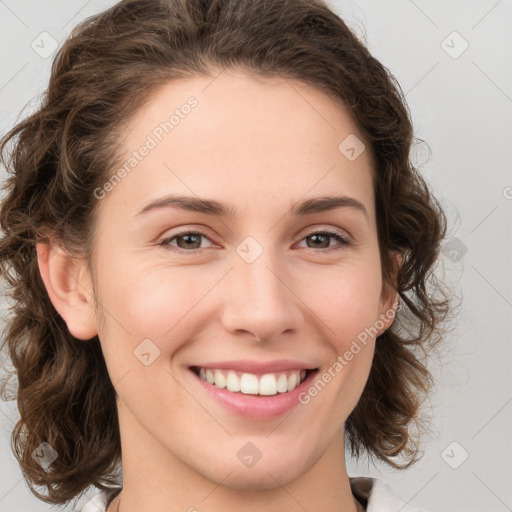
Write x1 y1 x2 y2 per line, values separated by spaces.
102 71 374 224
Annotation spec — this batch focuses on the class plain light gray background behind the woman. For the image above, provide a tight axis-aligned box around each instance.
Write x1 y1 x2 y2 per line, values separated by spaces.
0 0 512 512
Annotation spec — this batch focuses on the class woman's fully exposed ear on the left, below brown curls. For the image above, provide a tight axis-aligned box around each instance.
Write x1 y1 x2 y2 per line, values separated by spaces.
36 242 98 340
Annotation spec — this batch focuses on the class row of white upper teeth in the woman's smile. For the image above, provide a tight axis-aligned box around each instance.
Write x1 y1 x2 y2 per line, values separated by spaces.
199 368 306 396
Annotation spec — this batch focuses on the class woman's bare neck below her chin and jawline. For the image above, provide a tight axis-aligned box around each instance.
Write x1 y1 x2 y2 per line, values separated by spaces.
112 403 361 512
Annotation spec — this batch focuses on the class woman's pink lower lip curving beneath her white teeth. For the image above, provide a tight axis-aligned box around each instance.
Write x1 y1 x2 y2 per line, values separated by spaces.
189 369 318 420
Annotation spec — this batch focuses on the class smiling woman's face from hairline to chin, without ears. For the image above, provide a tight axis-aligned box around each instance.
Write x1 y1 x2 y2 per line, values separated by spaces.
88 71 394 488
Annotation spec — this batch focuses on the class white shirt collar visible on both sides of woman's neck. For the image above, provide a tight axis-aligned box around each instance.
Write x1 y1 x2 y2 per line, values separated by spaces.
80 477 422 512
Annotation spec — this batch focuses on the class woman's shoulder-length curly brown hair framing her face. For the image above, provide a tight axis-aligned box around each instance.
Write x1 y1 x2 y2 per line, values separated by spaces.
0 0 451 504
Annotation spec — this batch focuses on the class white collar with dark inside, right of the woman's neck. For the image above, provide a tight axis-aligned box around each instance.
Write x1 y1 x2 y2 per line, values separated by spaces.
349 476 422 512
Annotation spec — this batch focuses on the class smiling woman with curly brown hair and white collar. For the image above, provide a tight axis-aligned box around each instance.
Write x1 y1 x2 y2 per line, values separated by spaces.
0 0 449 512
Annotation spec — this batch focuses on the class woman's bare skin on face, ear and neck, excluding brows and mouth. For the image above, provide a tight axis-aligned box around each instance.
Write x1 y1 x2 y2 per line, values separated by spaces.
38 71 395 512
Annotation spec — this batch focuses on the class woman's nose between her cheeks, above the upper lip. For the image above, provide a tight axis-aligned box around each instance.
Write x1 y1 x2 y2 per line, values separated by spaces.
222 245 303 342
